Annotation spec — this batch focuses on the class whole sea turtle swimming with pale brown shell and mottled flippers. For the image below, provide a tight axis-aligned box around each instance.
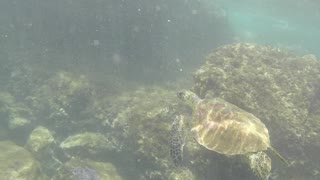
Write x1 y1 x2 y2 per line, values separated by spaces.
170 91 288 179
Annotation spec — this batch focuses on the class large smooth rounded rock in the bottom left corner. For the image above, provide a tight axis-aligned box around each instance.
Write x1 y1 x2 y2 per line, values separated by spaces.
0 141 44 180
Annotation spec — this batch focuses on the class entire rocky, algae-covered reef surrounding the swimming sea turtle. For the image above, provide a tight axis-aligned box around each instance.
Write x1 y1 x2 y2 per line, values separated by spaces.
0 43 320 180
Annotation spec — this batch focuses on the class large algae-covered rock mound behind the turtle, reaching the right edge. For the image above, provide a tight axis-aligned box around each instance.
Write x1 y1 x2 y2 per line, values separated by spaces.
193 43 320 179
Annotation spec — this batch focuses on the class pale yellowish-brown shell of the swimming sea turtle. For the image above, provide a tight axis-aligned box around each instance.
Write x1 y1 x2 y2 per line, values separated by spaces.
191 98 270 155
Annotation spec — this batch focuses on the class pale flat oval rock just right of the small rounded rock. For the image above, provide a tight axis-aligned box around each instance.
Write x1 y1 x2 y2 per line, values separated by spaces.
60 132 113 156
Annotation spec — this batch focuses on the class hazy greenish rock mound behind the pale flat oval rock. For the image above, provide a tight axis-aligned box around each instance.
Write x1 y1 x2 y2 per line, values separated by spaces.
26 71 94 139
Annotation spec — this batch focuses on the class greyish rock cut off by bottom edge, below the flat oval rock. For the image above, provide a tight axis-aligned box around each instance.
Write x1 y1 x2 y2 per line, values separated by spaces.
53 158 122 180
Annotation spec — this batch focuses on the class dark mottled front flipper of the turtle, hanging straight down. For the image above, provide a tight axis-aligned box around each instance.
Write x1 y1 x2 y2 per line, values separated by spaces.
169 115 185 166
